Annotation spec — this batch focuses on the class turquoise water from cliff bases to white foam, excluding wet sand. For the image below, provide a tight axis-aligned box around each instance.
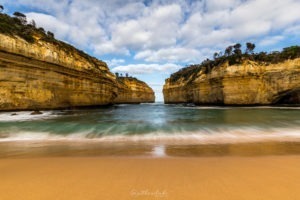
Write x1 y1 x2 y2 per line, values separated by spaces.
0 103 300 143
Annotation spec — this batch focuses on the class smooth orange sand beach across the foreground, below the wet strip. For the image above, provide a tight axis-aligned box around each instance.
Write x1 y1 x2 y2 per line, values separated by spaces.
0 155 300 200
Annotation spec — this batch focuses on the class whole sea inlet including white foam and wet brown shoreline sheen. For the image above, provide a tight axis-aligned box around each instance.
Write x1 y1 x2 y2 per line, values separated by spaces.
0 103 300 157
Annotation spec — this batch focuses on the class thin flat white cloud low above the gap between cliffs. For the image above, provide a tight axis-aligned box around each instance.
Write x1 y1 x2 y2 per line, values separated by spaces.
112 63 182 75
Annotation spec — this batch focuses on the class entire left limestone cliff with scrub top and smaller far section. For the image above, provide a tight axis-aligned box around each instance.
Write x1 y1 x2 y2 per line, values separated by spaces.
0 13 154 111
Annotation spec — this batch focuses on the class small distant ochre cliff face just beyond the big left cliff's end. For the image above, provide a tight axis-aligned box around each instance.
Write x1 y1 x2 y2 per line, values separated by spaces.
114 77 155 104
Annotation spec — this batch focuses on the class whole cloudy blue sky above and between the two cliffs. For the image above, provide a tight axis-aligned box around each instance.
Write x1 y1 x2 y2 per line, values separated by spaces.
0 0 300 101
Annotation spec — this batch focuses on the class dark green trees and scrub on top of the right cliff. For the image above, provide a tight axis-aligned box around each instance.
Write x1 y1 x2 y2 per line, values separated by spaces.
170 42 300 82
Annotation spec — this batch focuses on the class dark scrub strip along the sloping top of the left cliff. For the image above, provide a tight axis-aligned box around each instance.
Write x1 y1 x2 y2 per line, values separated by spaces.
0 13 106 69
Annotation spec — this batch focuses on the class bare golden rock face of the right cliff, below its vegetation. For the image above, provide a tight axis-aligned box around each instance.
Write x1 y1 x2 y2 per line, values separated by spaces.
163 59 300 105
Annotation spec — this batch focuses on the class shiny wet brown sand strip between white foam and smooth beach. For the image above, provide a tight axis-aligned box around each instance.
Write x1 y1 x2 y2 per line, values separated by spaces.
0 141 300 158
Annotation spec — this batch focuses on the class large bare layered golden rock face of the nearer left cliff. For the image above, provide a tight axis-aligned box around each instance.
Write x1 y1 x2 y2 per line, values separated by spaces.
0 34 118 110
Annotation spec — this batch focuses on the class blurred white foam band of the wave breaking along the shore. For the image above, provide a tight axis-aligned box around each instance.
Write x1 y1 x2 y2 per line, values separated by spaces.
0 128 300 144
